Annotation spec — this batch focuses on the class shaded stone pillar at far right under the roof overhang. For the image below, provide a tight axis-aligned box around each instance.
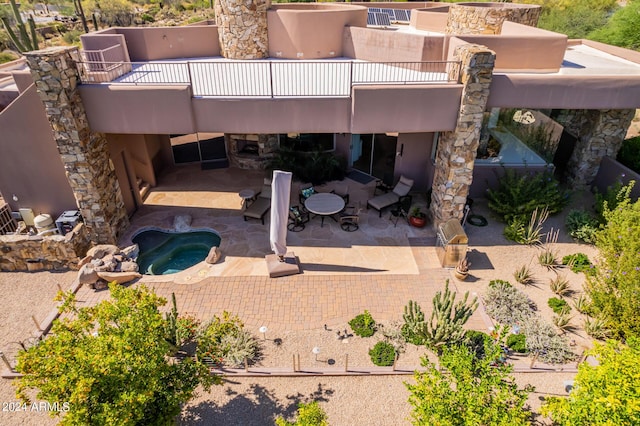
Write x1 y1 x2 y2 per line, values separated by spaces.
567 109 635 187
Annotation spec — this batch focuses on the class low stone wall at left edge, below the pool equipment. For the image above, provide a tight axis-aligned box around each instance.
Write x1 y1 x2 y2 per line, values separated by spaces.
0 223 91 272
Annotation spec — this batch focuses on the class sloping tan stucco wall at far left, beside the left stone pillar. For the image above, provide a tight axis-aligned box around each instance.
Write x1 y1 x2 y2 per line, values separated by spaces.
0 85 77 216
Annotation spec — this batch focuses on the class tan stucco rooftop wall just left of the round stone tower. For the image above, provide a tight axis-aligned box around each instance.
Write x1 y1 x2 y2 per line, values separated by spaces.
115 25 220 62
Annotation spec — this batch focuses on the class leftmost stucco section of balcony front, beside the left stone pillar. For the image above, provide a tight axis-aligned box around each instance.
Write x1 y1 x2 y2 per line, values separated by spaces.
79 85 195 133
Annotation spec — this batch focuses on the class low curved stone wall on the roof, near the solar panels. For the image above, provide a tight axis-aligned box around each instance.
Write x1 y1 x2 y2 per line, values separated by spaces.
445 4 508 34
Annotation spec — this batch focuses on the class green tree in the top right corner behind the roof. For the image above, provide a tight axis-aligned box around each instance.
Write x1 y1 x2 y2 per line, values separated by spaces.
589 0 640 50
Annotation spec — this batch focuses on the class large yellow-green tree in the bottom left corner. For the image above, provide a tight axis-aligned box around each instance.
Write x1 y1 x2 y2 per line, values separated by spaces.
17 284 220 425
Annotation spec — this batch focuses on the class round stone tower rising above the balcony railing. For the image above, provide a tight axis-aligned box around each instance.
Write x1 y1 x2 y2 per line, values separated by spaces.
215 0 271 59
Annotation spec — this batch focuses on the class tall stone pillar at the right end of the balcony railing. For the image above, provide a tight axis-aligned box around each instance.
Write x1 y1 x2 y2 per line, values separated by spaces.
431 44 496 226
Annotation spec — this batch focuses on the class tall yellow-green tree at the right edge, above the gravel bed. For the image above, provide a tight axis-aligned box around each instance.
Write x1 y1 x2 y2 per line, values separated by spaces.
585 181 640 340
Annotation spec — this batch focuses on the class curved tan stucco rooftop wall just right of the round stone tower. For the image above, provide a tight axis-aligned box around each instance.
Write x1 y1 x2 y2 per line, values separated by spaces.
267 3 367 59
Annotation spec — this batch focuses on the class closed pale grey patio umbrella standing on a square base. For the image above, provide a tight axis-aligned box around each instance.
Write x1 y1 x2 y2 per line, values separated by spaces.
269 170 291 262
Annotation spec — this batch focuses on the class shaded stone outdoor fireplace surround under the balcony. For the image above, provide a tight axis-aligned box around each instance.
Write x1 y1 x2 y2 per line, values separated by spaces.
224 133 280 170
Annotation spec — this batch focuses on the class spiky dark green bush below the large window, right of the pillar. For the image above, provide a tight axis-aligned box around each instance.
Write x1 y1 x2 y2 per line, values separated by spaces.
487 169 569 224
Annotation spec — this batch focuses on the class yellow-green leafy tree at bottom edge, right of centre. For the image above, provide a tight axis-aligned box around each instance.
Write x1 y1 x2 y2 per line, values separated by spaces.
405 344 533 426
